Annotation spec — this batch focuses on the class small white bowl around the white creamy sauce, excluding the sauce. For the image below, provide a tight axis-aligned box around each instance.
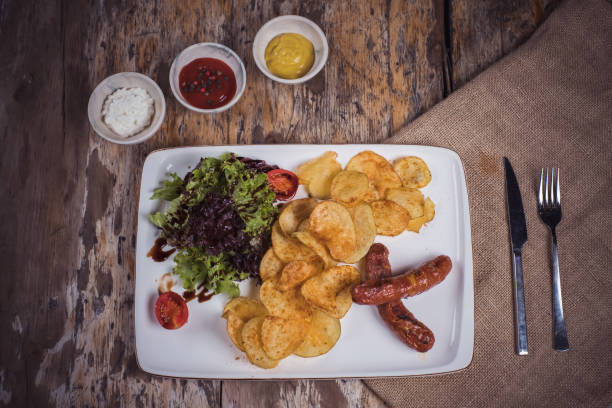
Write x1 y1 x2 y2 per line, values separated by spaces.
87 72 166 144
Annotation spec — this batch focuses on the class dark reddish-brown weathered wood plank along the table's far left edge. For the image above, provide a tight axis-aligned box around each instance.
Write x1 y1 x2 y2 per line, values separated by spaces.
0 1 87 406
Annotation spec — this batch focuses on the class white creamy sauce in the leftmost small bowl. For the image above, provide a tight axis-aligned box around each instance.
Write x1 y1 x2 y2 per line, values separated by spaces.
102 88 155 137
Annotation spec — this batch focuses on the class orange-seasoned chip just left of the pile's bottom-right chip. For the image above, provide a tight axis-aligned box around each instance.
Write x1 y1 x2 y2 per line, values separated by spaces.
261 316 309 360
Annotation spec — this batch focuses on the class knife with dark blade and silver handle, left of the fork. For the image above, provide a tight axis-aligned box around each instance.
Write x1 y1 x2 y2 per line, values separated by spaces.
504 157 527 355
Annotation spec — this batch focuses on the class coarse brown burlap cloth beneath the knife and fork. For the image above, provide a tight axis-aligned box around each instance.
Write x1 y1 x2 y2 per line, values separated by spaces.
366 0 612 407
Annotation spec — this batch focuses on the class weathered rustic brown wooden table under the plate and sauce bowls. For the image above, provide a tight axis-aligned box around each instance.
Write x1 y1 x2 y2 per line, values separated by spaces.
0 0 555 407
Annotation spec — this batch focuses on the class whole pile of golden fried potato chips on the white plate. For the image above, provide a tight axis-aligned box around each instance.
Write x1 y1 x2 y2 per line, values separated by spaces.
223 151 434 368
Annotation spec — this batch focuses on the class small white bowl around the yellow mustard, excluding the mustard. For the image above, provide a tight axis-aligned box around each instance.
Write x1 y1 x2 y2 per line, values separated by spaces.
253 15 329 84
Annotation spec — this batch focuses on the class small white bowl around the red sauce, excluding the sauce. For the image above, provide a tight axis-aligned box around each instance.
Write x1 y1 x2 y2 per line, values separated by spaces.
170 43 246 113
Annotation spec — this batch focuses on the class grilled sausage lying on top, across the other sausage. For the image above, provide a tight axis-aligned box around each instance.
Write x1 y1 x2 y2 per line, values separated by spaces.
351 255 452 305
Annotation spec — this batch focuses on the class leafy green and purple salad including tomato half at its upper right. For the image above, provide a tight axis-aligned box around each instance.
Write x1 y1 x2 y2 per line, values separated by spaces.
149 153 297 297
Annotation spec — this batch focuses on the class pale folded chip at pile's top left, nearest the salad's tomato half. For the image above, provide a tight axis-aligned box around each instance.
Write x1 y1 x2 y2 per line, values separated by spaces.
297 152 342 199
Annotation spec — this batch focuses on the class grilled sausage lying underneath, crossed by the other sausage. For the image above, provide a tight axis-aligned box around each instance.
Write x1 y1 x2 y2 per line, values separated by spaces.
366 244 436 353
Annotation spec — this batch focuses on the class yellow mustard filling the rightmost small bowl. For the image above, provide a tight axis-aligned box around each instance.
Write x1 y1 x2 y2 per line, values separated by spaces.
265 33 314 79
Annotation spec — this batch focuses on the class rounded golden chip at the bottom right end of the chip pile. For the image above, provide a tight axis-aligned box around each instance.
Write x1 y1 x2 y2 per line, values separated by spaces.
293 310 341 357
